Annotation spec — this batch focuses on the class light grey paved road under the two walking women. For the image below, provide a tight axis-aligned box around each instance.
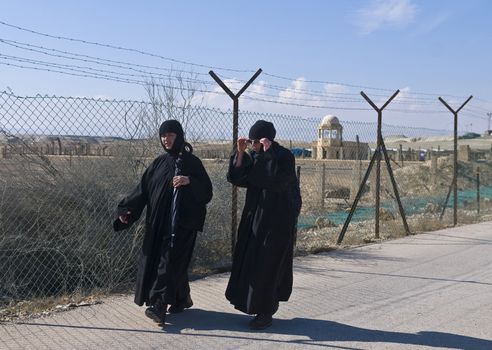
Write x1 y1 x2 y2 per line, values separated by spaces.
0 222 492 350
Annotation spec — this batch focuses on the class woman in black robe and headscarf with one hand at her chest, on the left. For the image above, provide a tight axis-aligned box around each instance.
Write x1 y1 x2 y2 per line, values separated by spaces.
114 120 212 324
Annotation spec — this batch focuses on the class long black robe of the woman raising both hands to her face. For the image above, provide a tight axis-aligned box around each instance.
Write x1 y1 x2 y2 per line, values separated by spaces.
226 142 297 314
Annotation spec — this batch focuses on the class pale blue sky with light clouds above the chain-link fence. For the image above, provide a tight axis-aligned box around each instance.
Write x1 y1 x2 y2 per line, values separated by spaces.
0 0 492 133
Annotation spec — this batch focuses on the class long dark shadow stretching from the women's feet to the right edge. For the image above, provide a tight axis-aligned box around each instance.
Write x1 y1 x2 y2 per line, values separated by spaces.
165 309 492 350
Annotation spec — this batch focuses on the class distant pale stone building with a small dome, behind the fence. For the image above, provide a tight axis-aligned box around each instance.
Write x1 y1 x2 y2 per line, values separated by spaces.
312 115 369 159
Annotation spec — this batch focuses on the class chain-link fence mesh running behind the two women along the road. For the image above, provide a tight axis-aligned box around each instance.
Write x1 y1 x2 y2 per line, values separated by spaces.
0 92 492 318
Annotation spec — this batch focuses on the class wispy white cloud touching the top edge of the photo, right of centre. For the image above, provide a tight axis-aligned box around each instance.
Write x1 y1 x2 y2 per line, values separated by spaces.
355 0 417 35
